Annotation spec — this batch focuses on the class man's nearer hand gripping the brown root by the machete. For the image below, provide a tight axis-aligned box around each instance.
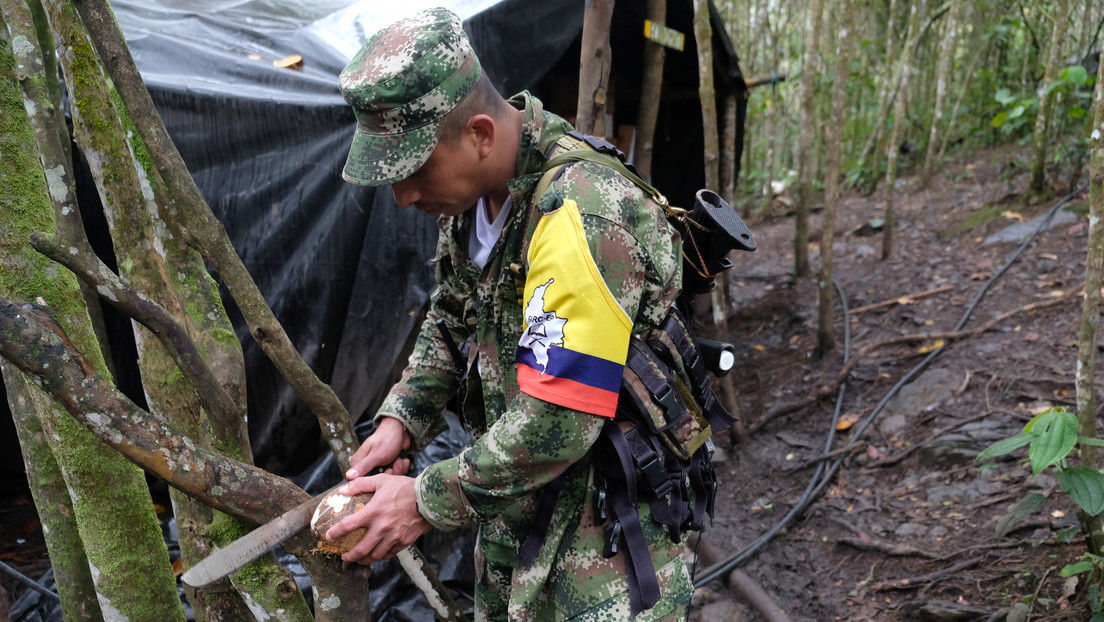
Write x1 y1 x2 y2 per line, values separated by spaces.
326 475 433 565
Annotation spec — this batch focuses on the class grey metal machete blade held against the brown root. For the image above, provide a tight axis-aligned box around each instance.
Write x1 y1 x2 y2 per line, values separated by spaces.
180 482 346 588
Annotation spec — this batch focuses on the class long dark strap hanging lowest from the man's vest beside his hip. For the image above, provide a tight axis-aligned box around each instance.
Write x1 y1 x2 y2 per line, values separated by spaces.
605 420 659 618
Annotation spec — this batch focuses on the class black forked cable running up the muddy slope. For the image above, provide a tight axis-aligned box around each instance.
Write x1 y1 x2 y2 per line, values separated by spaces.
694 183 1089 588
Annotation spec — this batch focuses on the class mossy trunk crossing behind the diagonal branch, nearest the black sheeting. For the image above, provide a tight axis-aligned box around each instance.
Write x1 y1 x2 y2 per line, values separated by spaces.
39 2 310 621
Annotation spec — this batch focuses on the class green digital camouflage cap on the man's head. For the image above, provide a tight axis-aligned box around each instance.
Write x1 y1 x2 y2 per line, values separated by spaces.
339 8 482 186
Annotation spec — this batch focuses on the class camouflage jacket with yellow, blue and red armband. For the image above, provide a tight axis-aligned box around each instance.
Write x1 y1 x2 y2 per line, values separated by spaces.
376 93 692 620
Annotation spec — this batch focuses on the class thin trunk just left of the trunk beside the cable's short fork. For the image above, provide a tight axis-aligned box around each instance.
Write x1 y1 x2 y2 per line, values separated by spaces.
794 0 824 277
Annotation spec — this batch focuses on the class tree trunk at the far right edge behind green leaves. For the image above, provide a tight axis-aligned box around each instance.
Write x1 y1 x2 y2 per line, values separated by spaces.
1076 28 1104 555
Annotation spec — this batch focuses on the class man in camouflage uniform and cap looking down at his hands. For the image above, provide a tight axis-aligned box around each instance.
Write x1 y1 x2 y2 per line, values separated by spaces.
328 9 692 620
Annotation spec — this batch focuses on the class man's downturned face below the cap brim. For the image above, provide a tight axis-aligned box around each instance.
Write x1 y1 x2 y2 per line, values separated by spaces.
391 140 482 215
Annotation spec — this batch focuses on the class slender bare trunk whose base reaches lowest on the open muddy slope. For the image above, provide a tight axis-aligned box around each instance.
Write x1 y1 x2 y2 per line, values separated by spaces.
817 0 854 357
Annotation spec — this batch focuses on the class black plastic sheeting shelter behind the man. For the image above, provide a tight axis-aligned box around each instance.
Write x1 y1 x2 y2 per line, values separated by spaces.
4 0 746 474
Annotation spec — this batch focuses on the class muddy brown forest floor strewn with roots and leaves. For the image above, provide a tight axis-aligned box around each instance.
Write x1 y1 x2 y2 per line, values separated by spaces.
0 145 1090 622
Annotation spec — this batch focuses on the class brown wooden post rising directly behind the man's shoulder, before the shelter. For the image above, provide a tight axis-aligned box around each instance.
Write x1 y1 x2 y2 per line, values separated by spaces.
575 0 614 136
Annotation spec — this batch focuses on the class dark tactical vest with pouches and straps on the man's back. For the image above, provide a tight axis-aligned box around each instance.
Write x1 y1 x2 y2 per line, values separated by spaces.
510 131 755 616
